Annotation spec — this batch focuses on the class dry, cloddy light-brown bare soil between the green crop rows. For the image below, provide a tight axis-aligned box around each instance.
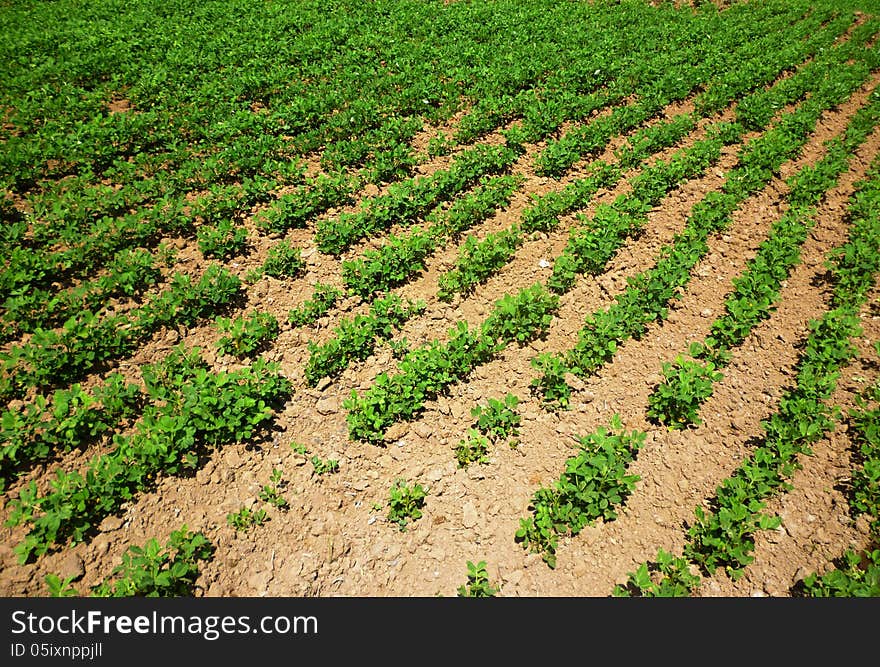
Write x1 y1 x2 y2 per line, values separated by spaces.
0 61 880 597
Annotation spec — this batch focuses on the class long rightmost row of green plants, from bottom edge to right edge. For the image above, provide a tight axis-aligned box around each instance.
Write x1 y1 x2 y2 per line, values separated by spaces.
615 155 880 596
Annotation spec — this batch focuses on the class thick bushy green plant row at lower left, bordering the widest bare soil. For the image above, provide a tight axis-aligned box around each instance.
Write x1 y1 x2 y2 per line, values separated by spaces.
7 346 292 563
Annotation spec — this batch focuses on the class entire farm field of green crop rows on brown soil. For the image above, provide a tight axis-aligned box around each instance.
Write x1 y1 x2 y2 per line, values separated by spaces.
0 0 880 597
